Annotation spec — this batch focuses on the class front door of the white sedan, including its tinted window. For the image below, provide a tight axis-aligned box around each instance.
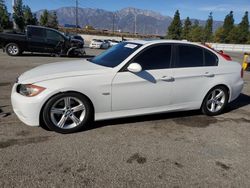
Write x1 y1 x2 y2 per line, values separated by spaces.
112 44 174 111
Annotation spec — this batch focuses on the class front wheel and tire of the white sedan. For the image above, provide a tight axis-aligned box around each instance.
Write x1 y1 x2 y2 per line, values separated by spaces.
42 92 93 134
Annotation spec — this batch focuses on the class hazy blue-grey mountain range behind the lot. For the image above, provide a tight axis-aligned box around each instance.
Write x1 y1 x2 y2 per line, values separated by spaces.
36 7 223 35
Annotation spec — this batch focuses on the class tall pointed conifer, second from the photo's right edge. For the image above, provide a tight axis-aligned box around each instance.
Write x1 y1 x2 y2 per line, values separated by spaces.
221 11 234 43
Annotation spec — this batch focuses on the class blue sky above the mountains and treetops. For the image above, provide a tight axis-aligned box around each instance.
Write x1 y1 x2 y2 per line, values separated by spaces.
5 0 250 23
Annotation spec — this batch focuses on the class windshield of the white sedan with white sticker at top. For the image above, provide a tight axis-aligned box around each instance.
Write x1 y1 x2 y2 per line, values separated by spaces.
89 42 142 68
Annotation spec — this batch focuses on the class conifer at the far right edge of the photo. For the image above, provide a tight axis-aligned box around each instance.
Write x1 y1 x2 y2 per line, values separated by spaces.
238 11 249 44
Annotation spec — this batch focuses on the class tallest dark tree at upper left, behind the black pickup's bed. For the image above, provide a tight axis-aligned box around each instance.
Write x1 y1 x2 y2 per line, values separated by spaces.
13 0 25 31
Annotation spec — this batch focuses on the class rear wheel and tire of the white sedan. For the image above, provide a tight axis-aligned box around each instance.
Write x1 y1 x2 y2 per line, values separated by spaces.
201 86 229 116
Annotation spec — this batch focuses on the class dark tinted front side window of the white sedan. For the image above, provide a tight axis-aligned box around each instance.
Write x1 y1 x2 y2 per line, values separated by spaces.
134 45 172 70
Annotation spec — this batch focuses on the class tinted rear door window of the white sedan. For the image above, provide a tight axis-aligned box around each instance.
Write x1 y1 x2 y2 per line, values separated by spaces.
177 45 203 68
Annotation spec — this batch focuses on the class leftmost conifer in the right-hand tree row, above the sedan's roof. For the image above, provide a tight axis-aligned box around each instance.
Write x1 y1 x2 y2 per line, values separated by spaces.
167 10 182 40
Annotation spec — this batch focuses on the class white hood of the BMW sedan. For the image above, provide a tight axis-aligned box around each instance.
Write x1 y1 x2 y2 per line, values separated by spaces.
18 60 111 84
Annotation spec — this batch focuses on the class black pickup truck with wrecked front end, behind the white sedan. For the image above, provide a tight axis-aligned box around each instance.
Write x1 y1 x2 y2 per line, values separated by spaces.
0 25 85 56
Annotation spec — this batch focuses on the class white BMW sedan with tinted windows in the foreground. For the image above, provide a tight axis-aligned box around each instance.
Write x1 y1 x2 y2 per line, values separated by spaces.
11 40 243 133
